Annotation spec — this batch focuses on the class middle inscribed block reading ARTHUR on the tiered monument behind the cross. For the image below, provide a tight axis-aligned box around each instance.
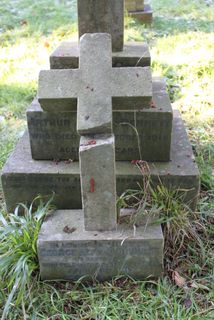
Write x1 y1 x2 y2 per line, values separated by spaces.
27 78 172 161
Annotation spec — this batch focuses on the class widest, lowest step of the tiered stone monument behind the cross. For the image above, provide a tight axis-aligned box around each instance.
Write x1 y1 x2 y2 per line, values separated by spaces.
2 113 199 212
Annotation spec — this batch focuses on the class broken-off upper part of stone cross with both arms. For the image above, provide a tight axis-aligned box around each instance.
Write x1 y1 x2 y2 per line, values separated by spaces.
38 33 152 135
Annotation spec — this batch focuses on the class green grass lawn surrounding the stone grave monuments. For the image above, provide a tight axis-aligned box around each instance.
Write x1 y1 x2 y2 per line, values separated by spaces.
0 0 214 320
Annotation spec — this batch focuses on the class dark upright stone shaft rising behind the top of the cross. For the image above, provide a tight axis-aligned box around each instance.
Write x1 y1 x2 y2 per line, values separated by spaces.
78 0 124 51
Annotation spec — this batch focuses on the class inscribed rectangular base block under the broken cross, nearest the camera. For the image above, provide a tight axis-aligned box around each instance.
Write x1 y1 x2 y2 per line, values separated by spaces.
37 210 164 281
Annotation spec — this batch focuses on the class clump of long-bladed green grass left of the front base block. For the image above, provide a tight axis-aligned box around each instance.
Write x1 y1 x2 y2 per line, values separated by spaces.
0 198 52 320
